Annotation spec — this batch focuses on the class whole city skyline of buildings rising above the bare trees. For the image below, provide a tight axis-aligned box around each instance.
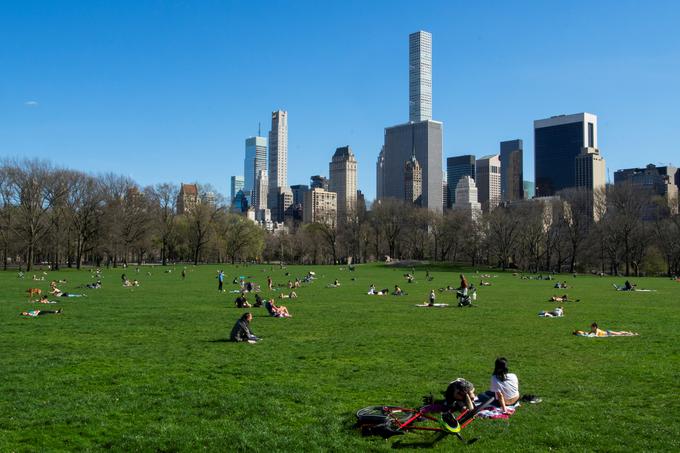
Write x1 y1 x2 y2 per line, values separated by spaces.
224 30 680 227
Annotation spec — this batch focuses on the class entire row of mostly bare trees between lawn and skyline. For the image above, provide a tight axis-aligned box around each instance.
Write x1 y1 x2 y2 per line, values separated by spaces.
0 160 680 275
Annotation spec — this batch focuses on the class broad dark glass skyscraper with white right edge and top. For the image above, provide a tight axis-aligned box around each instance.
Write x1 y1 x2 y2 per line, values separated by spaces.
534 113 597 197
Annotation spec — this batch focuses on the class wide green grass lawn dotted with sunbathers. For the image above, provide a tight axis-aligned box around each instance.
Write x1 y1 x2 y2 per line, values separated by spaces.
0 265 680 452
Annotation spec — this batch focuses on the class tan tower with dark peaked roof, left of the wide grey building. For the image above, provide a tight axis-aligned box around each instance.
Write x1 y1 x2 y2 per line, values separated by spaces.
328 146 357 222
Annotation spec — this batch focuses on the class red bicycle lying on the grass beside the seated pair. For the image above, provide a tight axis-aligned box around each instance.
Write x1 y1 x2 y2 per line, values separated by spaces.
356 397 494 443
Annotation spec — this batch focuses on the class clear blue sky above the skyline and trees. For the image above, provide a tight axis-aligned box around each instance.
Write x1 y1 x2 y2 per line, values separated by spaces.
0 0 680 199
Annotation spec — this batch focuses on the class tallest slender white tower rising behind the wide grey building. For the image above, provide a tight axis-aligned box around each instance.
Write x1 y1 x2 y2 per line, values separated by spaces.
408 31 432 122
